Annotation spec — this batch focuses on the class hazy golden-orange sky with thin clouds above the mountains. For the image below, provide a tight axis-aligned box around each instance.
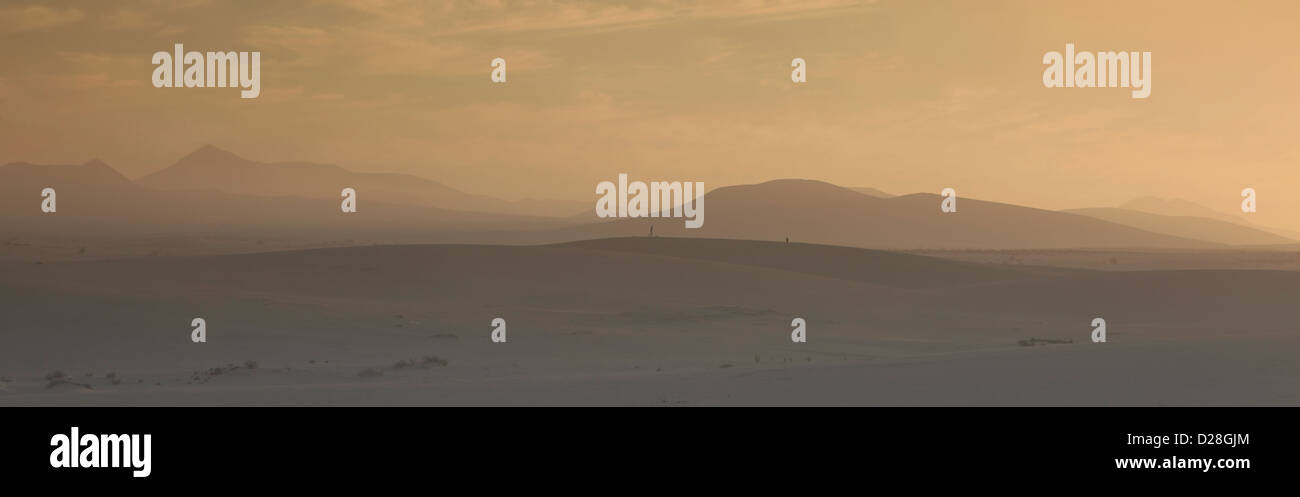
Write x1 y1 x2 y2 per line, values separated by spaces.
0 0 1300 228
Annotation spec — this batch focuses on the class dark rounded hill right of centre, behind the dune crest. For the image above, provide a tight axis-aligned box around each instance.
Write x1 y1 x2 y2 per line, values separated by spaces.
556 180 1219 250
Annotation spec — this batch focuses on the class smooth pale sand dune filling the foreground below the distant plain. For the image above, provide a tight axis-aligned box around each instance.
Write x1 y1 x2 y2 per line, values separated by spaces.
0 238 1300 405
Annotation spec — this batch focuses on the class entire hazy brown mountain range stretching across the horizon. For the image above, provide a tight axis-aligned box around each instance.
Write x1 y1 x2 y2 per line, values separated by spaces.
0 146 1294 250
